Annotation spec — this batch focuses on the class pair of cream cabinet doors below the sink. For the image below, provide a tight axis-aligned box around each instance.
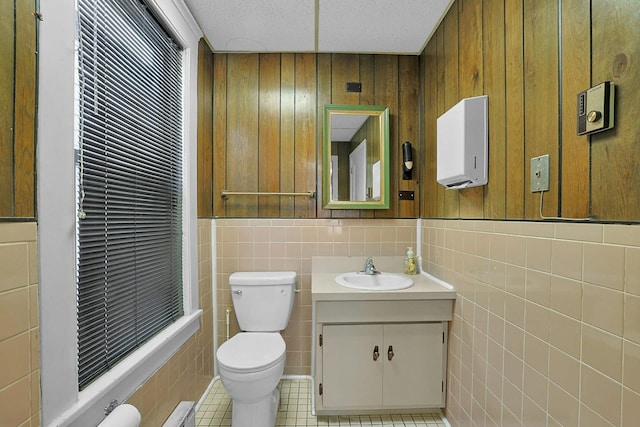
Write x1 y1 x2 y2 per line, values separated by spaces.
321 323 446 410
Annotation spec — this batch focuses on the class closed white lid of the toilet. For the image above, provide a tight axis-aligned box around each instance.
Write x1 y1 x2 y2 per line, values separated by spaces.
216 332 286 371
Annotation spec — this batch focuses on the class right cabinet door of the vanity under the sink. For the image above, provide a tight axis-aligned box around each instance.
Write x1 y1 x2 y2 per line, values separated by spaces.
381 323 444 408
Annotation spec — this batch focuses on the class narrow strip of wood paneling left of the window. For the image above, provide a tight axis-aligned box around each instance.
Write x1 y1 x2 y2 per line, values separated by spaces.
0 0 36 218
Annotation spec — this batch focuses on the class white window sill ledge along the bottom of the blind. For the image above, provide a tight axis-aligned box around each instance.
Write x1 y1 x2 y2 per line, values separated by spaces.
51 310 202 426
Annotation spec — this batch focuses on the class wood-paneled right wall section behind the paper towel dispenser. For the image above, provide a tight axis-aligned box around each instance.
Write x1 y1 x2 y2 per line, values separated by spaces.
420 0 640 222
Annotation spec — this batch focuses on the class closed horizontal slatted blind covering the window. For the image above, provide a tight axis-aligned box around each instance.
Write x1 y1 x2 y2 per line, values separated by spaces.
76 0 183 389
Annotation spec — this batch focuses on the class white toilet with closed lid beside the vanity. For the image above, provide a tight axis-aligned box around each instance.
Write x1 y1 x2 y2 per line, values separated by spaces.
216 271 296 427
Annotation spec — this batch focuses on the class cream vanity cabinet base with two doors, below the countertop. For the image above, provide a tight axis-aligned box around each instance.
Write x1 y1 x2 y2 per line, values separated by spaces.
314 300 452 415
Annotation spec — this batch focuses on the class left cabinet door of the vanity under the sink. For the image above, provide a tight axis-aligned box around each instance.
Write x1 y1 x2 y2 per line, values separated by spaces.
322 324 386 409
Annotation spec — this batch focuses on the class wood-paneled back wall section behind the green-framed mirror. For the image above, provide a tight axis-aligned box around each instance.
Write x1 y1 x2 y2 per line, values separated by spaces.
198 47 419 218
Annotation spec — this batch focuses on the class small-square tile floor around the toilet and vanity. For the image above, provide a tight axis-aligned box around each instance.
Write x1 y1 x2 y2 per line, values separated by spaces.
196 379 448 427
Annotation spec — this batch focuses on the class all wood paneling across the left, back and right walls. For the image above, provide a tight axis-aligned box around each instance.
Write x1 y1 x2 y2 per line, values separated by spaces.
0 0 640 222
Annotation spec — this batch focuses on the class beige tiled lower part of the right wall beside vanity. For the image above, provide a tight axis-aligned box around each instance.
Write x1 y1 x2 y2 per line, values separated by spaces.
425 220 640 426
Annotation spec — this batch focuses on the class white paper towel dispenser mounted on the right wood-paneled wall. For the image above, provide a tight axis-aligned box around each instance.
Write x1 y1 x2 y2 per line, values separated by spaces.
436 95 488 189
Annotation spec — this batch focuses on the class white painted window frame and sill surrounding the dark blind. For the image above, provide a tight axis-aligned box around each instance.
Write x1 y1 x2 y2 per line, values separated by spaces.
33 0 202 427
